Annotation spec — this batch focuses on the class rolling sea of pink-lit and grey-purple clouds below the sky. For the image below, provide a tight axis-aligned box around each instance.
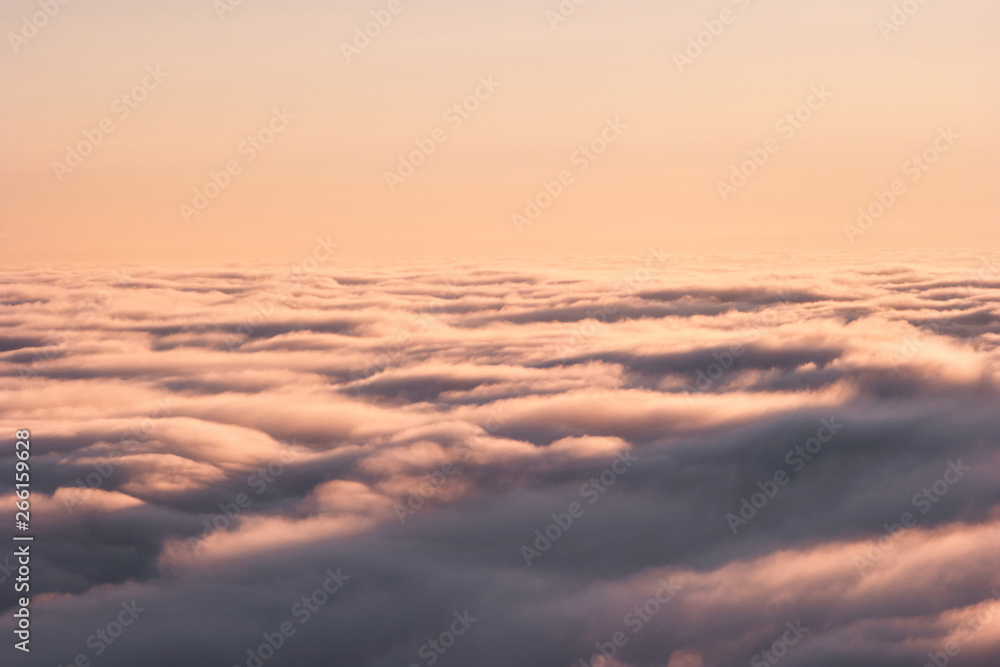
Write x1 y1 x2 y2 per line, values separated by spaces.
0 248 1000 667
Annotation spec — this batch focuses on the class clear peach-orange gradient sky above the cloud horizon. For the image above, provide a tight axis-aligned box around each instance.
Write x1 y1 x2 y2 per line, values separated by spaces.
0 0 1000 263
